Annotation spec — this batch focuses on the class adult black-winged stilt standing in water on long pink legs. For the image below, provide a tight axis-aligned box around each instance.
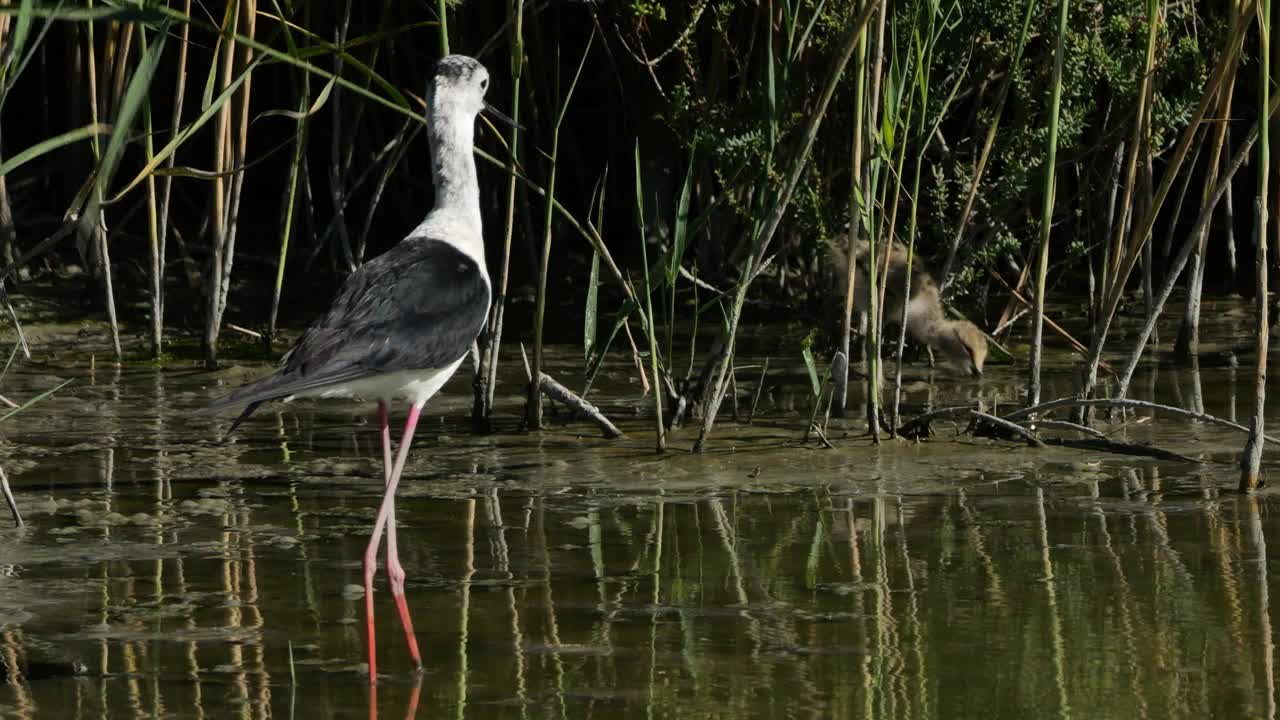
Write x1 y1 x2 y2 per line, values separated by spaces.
206 55 509 683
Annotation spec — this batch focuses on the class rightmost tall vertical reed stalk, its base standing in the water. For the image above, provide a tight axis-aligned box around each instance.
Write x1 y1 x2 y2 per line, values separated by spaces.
1240 0 1271 492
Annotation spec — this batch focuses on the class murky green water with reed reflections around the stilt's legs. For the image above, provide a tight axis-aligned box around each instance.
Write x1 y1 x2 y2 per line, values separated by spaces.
0 299 1280 719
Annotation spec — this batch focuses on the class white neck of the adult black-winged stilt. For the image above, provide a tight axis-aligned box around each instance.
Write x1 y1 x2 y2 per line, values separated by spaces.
415 106 485 268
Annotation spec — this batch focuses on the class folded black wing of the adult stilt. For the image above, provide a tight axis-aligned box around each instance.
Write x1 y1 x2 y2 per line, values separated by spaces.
205 237 490 424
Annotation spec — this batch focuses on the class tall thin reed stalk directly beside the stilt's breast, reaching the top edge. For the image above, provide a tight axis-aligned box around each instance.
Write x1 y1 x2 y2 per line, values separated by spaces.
471 0 525 427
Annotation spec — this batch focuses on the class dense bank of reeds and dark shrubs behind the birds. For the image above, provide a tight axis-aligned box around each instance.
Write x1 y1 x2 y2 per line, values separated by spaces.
0 0 1280 476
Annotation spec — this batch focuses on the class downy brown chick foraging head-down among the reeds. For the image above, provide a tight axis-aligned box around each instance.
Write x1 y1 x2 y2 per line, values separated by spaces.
831 234 987 378
